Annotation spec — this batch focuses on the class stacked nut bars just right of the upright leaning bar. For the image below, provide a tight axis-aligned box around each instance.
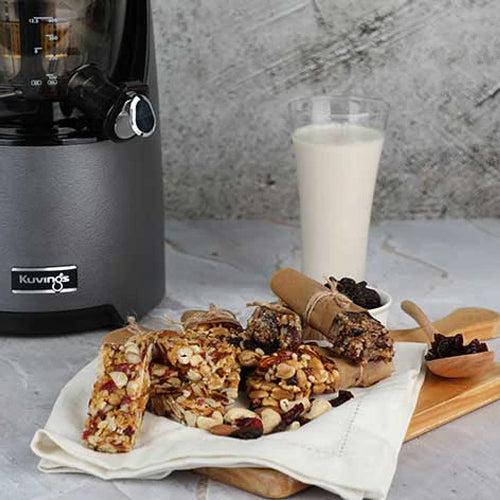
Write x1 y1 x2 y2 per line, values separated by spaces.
148 331 240 429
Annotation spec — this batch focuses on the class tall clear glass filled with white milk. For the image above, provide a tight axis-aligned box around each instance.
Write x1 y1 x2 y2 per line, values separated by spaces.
289 96 388 281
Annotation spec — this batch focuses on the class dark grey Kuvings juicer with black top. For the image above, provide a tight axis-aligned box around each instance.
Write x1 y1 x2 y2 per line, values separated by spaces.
0 0 164 334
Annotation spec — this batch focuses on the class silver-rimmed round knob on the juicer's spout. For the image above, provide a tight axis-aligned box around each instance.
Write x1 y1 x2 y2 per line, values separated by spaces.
114 92 156 140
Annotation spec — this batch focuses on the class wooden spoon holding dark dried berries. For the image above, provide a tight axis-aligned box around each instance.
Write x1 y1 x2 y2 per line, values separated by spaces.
401 300 495 378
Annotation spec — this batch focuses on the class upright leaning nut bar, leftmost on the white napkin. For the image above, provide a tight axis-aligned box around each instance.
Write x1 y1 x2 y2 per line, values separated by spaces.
82 328 153 453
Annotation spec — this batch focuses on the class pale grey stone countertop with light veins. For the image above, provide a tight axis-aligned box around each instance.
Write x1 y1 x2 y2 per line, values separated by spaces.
0 220 500 500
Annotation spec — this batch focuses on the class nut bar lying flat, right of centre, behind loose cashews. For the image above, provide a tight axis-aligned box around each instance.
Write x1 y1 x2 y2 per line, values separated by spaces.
246 344 339 411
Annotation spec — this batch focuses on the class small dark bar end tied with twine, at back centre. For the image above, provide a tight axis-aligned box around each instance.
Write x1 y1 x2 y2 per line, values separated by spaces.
244 303 302 354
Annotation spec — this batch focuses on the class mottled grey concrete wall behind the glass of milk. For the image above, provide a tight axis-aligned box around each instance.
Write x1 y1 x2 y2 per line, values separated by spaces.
152 0 500 219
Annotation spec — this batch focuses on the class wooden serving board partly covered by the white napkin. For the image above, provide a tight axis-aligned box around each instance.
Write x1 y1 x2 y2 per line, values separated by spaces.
196 307 500 498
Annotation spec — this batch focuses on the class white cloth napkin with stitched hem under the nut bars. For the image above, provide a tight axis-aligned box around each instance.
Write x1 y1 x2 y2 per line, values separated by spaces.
31 343 424 500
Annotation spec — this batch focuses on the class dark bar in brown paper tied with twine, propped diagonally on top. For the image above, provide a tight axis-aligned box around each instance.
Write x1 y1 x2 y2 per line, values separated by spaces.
271 269 394 365
